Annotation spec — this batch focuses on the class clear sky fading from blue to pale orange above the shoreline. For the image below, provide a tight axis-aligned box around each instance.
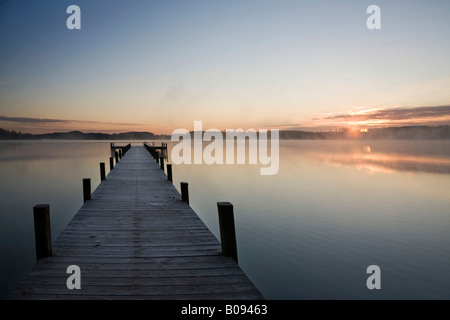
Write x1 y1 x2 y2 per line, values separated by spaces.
0 0 450 134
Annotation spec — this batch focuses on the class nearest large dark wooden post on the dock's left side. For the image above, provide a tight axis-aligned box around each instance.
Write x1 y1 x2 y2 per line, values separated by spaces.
33 204 52 260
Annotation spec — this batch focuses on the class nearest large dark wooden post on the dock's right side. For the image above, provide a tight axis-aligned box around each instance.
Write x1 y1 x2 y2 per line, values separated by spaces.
217 202 238 262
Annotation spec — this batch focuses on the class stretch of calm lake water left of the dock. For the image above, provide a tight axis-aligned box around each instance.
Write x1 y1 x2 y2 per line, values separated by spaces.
0 141 114 298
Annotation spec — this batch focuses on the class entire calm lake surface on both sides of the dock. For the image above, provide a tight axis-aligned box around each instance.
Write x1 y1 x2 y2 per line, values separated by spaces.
0 141 450 299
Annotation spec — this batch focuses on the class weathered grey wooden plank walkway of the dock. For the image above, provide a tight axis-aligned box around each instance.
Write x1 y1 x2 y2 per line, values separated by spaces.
10 146 263 299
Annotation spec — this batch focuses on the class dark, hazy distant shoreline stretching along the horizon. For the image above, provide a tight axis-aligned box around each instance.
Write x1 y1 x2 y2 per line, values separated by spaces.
0 125 450 141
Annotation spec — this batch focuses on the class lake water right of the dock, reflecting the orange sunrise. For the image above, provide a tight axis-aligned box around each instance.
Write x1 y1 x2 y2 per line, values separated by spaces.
169 141 450 299
